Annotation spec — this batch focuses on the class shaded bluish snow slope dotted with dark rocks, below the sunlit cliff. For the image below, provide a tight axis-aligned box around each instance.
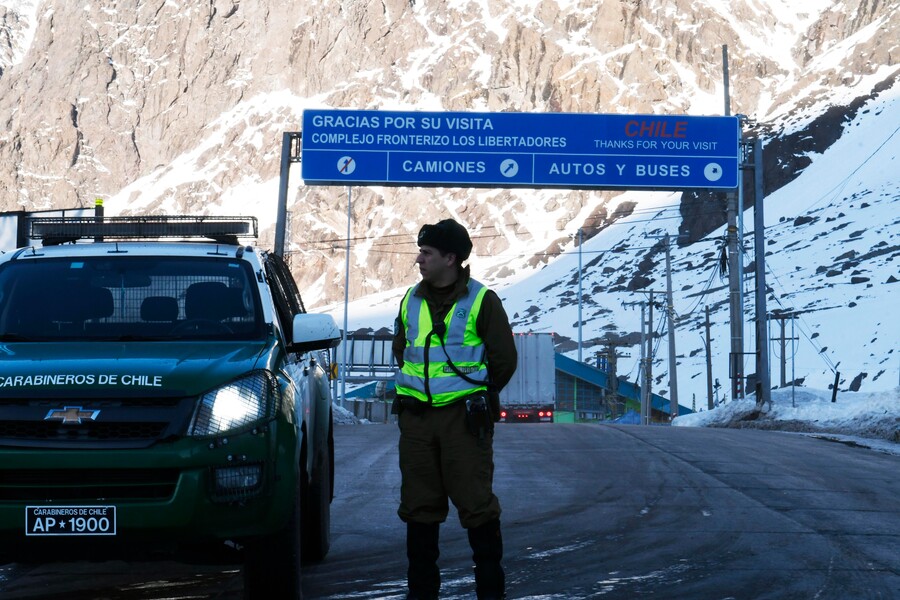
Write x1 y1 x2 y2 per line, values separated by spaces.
332 90 900 411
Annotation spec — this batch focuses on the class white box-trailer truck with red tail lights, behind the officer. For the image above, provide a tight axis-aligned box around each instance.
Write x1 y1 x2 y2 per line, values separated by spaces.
500 333 556 423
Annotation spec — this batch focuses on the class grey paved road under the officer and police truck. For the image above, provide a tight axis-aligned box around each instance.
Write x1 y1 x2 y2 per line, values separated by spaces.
0 424 900 600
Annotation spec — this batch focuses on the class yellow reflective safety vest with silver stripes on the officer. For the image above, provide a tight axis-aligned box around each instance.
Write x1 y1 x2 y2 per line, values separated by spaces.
396 279 488 406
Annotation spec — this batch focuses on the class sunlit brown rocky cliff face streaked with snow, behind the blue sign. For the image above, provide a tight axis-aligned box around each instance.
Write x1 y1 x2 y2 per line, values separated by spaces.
0 0 900 302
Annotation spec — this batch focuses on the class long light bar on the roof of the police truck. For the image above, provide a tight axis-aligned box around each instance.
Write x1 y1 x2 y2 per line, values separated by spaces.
29 216 257 245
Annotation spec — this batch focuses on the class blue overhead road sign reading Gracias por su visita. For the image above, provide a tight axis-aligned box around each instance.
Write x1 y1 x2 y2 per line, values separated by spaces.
301 110 740 190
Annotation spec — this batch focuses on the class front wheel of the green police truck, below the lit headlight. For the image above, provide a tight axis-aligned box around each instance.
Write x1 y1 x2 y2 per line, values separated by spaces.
244 482 303 600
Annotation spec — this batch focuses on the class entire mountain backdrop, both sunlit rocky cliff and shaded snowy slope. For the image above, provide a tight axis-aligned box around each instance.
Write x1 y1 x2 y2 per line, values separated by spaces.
0 0 900 407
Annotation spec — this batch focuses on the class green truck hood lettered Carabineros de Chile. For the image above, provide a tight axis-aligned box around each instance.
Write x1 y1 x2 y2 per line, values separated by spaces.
0 339 275 399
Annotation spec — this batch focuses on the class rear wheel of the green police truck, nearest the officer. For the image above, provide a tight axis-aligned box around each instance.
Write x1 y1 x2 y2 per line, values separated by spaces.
301 414 334 562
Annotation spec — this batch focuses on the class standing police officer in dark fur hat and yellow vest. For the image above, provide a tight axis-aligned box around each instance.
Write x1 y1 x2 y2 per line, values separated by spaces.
393 219 516 600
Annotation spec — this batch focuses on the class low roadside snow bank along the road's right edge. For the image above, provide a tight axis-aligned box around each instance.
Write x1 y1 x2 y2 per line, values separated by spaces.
672 387 900 449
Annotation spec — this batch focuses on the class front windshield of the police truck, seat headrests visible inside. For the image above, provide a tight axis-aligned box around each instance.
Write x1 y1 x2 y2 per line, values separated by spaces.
0 255 265 342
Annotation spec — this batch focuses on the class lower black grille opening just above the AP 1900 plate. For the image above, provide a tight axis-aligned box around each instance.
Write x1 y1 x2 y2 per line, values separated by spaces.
0 469 179 502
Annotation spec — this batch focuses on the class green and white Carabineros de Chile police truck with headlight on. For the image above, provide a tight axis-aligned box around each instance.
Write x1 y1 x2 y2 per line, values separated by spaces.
0 217 340 598
